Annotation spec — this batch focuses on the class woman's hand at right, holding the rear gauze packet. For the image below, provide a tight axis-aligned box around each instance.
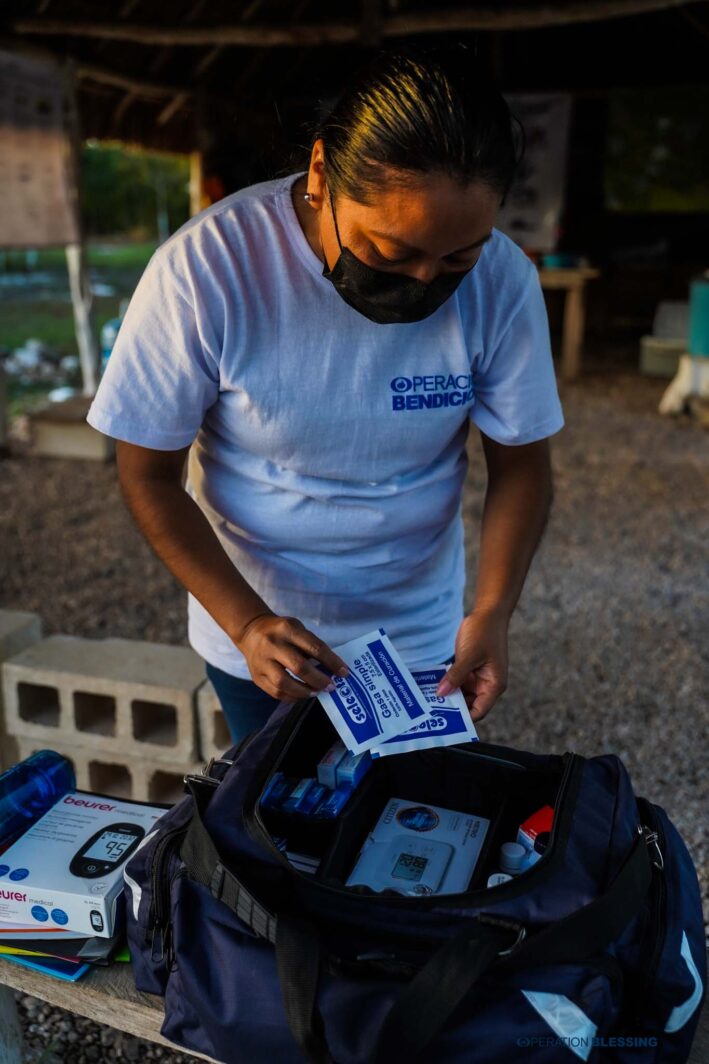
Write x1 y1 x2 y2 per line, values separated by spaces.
438 610 509 720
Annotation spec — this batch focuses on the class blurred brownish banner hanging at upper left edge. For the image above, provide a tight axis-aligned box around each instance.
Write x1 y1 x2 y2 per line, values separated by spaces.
0 51 79 248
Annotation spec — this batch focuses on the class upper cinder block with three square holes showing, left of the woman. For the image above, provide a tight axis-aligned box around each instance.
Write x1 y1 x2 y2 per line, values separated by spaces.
2 635 204 765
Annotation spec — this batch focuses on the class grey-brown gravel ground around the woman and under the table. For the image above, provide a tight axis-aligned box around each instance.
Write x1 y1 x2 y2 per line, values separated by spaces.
0 366 709 1064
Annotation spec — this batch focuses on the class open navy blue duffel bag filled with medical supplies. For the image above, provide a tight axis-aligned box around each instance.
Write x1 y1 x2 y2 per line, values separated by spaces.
121 698 706 1064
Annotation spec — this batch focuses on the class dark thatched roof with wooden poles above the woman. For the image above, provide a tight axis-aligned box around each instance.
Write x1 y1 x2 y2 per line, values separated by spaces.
0 0 709 154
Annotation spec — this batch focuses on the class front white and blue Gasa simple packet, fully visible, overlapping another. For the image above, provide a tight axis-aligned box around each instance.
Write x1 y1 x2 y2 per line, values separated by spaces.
317 628 430 753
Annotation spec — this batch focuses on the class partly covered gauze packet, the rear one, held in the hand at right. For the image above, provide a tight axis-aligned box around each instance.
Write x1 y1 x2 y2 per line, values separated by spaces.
372 665 479 758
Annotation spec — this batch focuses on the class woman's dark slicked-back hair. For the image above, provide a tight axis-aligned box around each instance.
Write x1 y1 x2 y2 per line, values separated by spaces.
311 44 524 204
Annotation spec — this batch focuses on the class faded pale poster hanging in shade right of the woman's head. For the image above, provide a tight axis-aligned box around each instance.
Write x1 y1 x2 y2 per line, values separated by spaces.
495 93 572 251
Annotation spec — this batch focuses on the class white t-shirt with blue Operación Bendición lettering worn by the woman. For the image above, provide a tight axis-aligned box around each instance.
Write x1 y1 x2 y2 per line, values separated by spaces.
87 173 563 678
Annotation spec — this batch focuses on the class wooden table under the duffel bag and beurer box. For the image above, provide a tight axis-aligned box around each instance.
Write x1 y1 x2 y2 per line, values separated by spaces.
0 959 709 1064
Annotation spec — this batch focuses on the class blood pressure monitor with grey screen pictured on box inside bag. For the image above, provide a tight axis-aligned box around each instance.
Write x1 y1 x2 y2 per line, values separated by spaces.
347 835 454 897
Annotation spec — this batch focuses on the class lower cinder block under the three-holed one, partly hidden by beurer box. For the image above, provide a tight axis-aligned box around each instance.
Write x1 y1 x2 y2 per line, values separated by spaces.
18 738 202 804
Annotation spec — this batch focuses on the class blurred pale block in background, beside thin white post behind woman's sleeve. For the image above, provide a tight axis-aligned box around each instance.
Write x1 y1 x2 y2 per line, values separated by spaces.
30 396 115 462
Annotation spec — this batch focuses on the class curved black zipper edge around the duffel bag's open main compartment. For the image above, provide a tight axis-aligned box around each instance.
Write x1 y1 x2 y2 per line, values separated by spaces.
244 699 582 910
